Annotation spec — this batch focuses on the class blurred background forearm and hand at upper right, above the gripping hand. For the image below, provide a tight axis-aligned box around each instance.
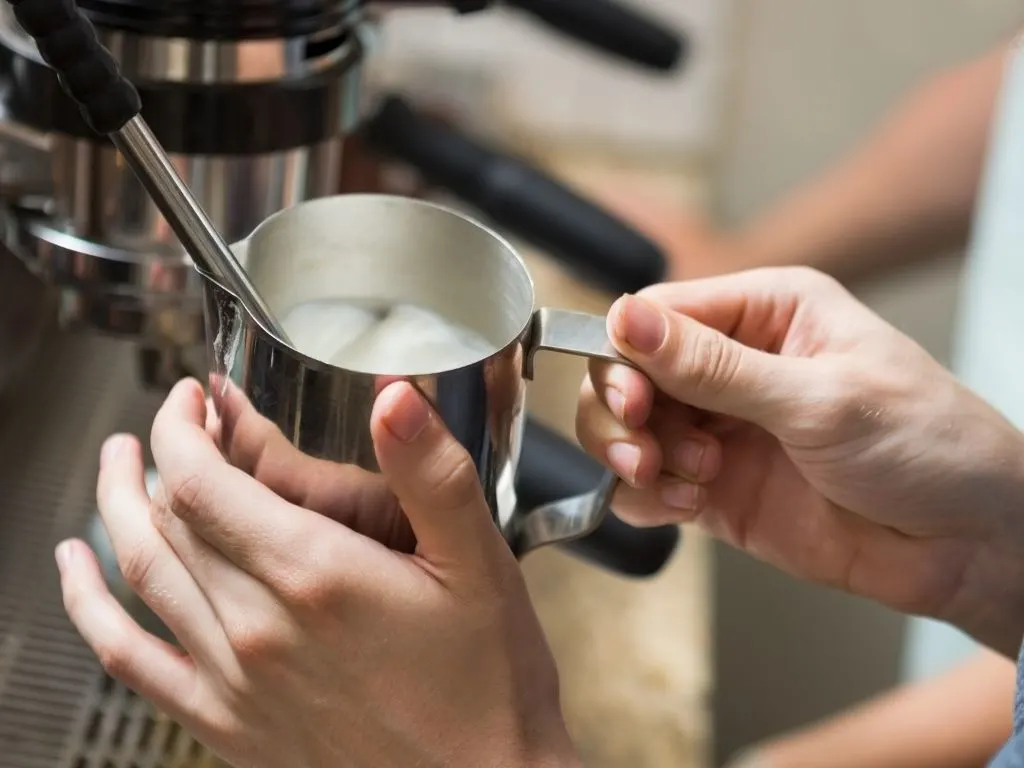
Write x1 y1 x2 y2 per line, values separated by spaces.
602 43 1012 280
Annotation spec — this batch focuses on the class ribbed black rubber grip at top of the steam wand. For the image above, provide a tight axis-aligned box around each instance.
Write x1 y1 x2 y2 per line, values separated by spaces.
8 0 142 135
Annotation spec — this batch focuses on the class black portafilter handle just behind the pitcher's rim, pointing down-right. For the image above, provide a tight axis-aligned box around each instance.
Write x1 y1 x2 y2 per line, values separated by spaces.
366 96 666 293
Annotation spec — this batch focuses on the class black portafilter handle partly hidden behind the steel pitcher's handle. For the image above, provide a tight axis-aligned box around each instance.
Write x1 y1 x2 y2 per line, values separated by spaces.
516 420 680 577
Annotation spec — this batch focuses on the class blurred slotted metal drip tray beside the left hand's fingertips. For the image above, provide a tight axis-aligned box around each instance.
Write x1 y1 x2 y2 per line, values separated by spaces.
0 334 219 768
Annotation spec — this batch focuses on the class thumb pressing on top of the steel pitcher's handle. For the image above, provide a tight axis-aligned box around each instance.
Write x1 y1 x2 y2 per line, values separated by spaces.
608 296 808 431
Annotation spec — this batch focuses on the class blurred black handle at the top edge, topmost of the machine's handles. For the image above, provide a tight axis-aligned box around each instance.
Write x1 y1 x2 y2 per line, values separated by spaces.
506 0 686 72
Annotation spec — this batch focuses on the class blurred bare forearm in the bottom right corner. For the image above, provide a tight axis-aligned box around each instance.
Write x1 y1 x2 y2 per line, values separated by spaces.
752 651 1015 768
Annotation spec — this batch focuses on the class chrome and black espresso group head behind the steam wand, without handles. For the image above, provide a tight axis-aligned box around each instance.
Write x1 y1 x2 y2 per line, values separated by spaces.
0 0 365 386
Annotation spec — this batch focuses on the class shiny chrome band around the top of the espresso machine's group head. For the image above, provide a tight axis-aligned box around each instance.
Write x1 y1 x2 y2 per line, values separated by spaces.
0 0 361 84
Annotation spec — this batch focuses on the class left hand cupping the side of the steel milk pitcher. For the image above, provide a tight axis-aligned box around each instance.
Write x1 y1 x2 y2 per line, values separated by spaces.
57 381 574 768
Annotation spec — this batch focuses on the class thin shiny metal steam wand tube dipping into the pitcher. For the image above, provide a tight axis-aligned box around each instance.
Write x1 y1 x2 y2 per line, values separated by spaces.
111 115 288 341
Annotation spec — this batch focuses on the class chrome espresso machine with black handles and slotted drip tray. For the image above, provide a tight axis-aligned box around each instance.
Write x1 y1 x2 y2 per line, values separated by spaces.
0 0 686 768
